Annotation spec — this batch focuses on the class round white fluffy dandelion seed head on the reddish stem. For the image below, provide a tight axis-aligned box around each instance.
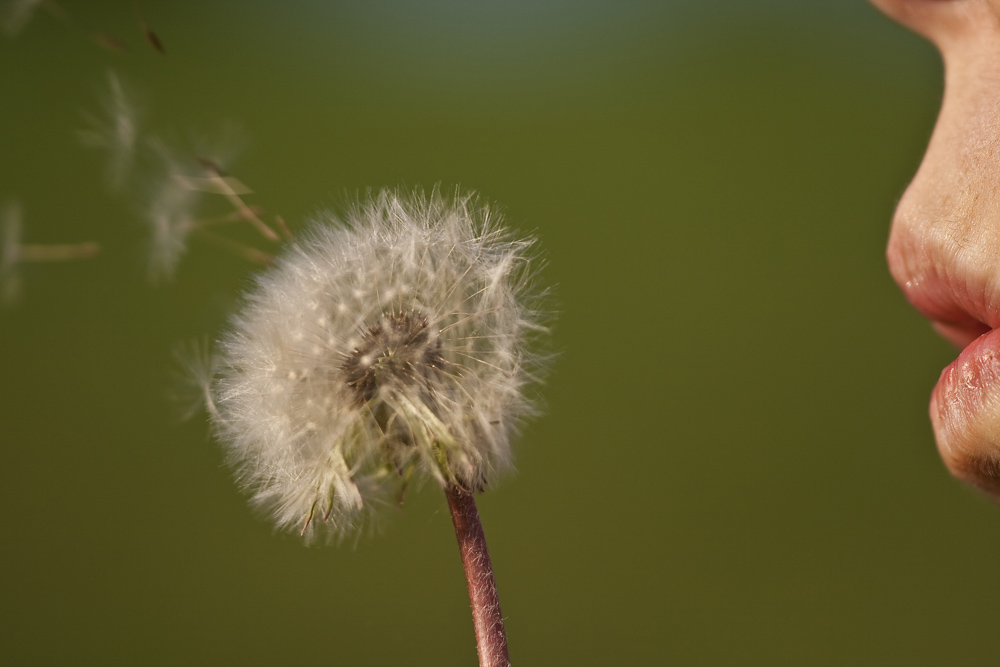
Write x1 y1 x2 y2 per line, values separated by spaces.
211 190 545 538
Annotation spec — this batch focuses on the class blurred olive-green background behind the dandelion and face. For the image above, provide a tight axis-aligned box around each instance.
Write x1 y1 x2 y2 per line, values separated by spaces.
0 0 1000 665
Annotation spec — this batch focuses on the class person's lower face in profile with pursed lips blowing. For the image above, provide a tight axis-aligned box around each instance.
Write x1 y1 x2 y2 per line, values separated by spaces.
872 0 1000 500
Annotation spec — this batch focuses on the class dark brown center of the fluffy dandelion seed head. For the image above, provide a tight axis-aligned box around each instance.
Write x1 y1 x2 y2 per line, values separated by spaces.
341 312 442 404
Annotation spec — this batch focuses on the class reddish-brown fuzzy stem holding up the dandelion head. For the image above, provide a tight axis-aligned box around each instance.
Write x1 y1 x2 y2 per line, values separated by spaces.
445 484 510 667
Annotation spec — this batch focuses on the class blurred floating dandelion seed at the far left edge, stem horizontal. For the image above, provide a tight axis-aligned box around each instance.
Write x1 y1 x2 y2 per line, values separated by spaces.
0 202 100 306
